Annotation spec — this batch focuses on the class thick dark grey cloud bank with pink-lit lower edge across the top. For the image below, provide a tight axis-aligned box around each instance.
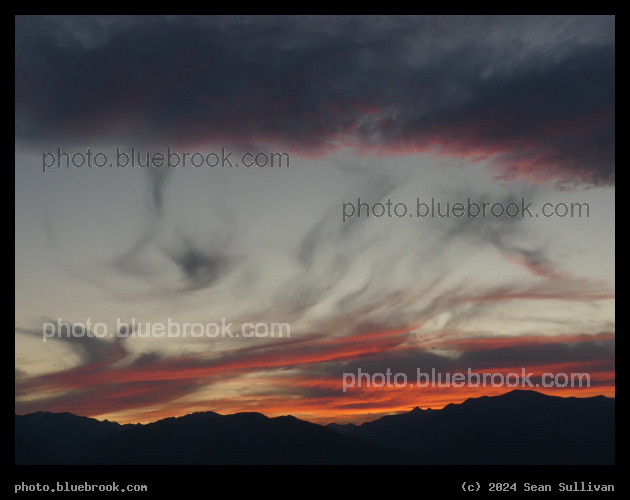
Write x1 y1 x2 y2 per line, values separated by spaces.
15 16 615 188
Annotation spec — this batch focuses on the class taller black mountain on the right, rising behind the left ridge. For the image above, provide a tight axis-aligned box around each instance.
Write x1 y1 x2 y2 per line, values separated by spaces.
328 390 615 465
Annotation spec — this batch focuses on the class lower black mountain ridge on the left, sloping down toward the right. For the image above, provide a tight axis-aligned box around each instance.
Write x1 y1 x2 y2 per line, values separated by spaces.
15 412 412 465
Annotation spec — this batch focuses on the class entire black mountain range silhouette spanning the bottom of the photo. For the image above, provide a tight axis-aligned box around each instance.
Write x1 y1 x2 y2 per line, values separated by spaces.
15 391 615 465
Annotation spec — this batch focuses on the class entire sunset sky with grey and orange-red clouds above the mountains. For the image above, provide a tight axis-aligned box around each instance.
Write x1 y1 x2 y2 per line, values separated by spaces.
15 16 615 423
